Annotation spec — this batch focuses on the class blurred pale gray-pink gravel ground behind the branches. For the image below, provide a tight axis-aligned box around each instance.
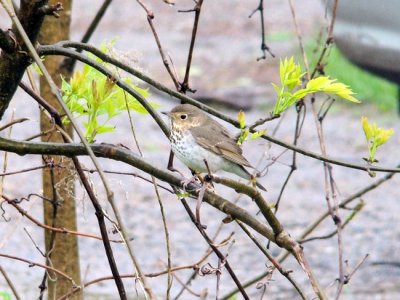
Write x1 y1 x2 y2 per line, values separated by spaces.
0 0 400 299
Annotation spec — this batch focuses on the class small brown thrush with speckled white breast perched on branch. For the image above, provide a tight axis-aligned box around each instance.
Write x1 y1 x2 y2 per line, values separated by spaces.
166 104 266 191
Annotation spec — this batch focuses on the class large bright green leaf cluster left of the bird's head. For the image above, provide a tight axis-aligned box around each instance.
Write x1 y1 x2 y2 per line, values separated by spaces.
61 40 156 143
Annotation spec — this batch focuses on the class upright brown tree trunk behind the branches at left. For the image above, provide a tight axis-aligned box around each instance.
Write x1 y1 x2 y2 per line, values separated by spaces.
39 0 82 299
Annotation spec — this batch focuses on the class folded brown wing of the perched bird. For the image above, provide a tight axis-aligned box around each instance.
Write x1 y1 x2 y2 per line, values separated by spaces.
190 118 251 167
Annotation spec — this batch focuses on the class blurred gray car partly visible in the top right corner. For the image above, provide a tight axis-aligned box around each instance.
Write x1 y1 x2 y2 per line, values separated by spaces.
328 0 400 84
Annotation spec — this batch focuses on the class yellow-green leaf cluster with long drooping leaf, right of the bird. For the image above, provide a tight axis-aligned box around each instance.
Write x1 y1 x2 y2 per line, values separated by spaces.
272 57 360 115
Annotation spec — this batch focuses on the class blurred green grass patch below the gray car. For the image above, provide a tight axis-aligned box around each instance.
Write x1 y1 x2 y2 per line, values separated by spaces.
306 45 397 111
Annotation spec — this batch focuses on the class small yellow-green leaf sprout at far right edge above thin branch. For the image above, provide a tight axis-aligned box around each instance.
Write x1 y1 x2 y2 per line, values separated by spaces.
361 117 394 164
